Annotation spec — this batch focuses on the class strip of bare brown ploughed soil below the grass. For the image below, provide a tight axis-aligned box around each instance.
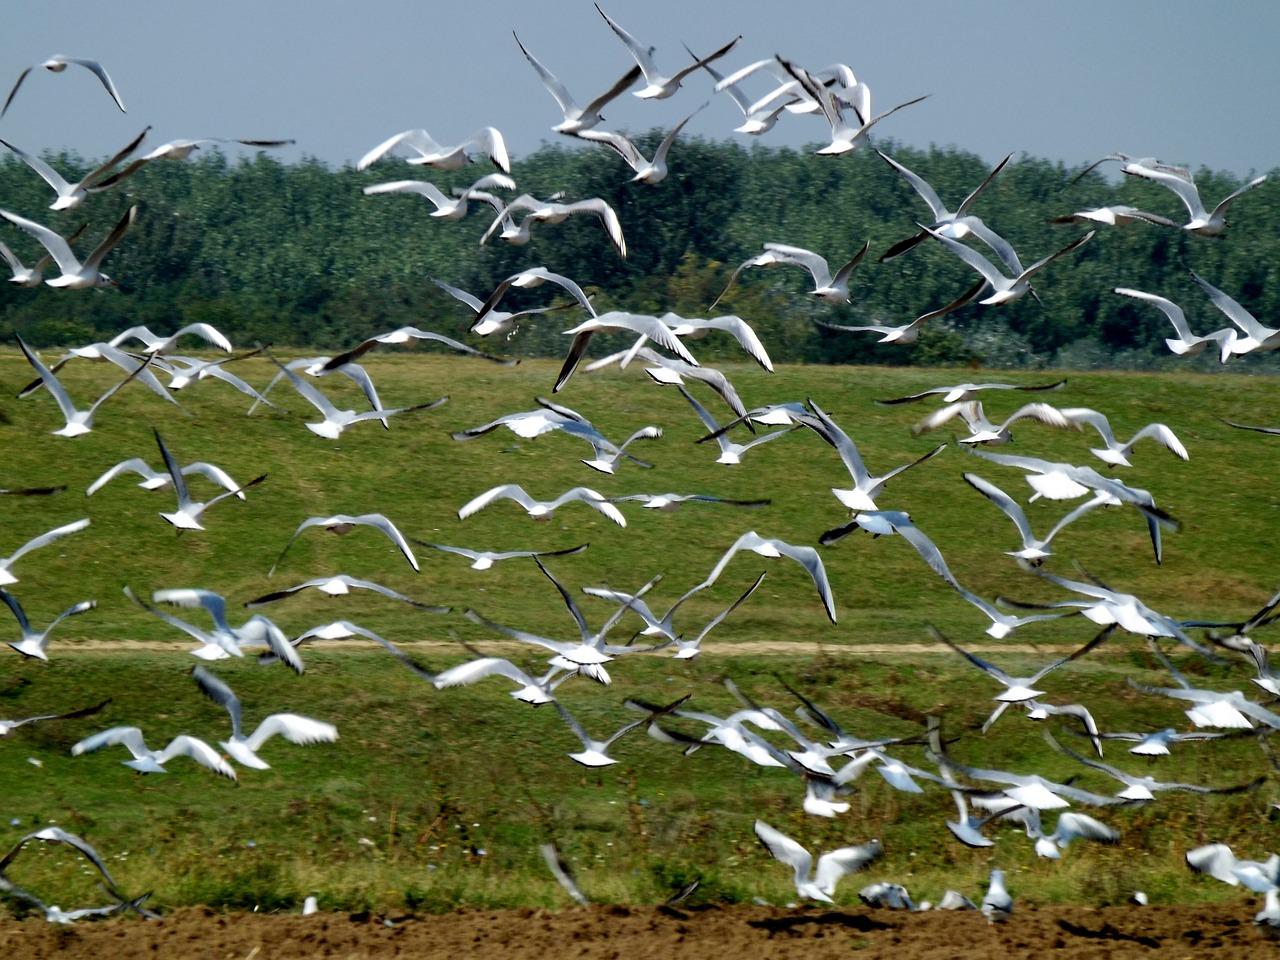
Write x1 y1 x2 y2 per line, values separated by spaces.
0 900 1280 960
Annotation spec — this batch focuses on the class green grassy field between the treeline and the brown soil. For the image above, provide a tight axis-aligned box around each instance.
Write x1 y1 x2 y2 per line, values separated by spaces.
0 348 1280 910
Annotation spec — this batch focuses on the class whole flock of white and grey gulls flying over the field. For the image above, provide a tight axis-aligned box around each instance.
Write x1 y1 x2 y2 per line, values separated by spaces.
0 8 1280 929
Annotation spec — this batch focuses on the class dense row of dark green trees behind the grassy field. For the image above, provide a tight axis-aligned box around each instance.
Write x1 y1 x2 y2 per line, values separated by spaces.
0 132 1280 367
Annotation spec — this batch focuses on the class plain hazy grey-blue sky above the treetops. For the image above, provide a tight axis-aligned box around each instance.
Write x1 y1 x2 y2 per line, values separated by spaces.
0 0 1280 177
